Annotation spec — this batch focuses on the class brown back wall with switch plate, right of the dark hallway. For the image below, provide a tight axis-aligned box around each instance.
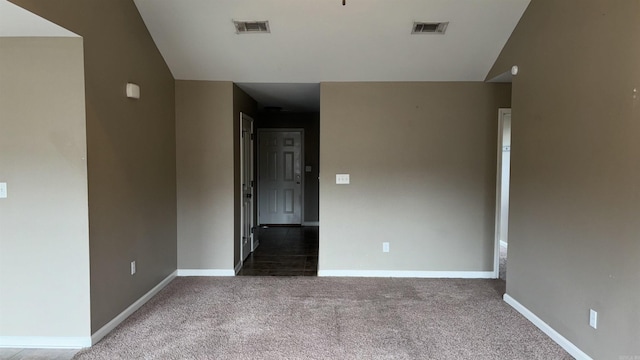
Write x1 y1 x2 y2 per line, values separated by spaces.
319 82 510 273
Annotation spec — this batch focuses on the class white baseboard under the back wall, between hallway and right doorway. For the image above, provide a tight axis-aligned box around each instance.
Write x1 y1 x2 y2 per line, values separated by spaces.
318 270 495 279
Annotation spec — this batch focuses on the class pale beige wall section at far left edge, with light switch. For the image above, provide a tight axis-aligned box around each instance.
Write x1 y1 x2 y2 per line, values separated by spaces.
0 37 91 341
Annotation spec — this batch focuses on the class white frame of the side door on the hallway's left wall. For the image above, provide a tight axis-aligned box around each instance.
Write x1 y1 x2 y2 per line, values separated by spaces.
239 112 259 265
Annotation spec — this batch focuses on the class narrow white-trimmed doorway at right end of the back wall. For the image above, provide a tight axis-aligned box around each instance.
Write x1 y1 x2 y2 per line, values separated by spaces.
494 109 511 281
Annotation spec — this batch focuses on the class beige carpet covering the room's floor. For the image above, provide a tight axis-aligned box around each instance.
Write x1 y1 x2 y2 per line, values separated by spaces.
74 277 571 360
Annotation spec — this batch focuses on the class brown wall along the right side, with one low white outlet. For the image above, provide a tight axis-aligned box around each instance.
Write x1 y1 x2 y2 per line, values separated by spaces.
488 0 640 359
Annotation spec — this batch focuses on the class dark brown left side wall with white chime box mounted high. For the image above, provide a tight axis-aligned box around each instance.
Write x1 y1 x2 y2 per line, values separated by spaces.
13 0 176 332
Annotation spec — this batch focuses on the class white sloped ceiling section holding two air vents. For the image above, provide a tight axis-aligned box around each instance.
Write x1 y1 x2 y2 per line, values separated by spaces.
135 0 529 84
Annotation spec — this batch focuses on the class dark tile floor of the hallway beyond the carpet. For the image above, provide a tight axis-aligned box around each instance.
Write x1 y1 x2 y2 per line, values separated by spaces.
238 226 318 276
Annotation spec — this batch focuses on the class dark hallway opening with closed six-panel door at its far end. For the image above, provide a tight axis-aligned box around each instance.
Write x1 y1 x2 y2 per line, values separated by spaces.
237 110 320 276
